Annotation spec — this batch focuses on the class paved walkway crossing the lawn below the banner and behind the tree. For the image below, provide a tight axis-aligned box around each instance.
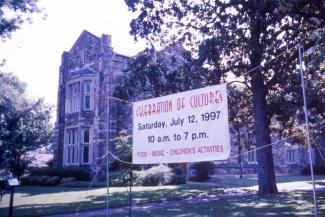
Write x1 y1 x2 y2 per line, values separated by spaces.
46 182 325 217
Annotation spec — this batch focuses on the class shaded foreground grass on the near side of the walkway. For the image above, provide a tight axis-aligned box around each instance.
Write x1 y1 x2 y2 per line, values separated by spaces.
109 192 325 217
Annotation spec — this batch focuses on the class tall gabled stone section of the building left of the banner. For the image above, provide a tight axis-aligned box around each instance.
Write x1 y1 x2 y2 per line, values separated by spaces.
54 31 130 170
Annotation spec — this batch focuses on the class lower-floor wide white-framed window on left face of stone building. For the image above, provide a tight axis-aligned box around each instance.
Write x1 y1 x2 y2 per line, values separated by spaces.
65 128 79 164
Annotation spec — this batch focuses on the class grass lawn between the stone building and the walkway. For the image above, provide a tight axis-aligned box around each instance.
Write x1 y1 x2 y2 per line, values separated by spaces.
0 176 325 216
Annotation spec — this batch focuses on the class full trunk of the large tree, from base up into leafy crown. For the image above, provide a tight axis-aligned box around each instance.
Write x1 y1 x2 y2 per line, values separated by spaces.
250 8 278 195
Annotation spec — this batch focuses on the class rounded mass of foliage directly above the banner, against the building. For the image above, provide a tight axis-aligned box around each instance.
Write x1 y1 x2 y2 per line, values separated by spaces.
115 45 206 100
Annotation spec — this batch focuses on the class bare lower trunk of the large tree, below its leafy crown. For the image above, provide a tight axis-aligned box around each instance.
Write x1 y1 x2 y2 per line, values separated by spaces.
251 71 278 195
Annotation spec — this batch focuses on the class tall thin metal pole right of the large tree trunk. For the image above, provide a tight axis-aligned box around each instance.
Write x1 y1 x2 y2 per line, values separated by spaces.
298 44 318 217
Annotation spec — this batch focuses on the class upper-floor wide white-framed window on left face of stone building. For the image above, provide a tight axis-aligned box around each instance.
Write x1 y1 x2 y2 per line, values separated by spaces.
66 82 80 112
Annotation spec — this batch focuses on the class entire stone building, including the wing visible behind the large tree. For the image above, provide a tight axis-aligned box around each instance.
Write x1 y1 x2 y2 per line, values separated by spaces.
54 31 314 175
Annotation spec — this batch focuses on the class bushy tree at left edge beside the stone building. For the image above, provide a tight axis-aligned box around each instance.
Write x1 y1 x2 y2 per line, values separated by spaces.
0 72 52 176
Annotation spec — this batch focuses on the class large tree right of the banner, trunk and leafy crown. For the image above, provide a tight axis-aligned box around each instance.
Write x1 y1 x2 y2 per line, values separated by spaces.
126 0 325 194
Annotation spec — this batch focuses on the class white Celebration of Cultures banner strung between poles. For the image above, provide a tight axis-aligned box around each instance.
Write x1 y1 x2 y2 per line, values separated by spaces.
133 84 230 164
